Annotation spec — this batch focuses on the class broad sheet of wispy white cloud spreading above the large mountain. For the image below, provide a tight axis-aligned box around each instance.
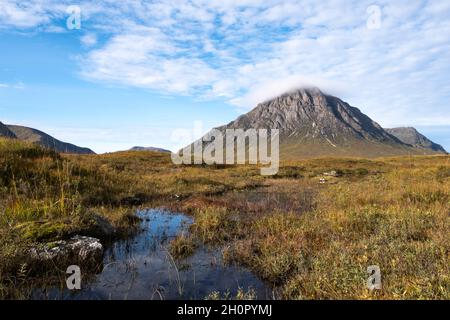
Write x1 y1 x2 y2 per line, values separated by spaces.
0 0 450 126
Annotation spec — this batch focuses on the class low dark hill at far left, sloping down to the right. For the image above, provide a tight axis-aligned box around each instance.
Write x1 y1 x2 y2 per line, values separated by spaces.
6 125 94 154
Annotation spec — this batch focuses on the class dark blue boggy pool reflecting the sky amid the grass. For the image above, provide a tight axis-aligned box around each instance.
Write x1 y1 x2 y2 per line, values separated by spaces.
35 209 272 300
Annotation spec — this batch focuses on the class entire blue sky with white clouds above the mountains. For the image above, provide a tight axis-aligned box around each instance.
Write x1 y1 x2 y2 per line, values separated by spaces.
0 0 450 152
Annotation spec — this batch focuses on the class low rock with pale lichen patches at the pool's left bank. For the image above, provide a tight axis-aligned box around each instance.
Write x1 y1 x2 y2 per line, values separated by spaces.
30 236 103 263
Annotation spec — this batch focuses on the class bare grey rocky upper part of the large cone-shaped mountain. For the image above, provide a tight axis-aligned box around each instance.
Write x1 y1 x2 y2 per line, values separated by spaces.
226 88 398 143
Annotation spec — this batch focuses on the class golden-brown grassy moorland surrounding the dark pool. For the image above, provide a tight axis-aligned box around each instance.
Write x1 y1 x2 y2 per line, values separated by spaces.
0 139 450 299
